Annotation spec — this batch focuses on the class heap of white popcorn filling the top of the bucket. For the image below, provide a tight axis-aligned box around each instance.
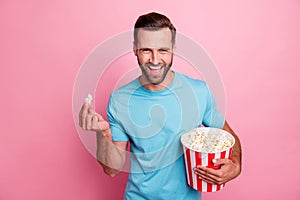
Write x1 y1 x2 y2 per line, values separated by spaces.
182 129 234 152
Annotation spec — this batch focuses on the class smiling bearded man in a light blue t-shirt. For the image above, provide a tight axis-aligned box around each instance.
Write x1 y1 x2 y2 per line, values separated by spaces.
79 13 241 199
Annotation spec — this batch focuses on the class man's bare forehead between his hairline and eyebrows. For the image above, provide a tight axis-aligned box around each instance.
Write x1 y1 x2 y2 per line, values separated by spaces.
137 28 172 48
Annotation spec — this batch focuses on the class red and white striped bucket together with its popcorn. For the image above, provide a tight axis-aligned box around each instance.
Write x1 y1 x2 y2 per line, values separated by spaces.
181 127 235 192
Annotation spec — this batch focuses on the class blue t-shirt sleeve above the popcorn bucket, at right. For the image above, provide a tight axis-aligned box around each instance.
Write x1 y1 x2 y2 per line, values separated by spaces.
203 84 225 128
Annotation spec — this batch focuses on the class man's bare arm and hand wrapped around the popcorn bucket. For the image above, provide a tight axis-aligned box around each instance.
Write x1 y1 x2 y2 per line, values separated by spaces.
194 121 242 185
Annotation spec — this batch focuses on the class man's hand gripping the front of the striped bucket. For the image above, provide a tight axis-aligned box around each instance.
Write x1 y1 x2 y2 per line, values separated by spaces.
194 158 241 185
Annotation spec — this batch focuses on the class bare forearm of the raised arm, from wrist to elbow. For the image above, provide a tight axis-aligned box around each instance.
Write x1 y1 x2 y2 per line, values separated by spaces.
97 133 125 176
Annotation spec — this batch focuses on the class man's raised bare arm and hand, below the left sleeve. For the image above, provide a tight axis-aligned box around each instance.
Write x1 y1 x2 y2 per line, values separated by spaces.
79 103 127 177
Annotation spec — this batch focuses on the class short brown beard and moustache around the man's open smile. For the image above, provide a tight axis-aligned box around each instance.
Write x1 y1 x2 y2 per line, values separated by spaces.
137 57 173 85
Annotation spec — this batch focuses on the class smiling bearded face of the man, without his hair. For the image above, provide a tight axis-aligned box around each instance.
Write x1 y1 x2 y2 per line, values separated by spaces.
134 28 173 85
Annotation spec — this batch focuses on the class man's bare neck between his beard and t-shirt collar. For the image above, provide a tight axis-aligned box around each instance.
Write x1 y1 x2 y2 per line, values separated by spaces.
139 70 175 91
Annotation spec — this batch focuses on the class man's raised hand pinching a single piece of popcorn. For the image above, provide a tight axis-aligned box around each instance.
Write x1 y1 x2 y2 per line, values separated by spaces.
79 103 111 138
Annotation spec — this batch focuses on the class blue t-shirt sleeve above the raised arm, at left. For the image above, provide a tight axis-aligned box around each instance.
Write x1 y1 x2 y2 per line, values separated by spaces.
106 95 129 142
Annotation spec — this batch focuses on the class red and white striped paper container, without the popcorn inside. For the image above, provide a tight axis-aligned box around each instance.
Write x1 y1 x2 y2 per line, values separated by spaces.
181 127 235 192
